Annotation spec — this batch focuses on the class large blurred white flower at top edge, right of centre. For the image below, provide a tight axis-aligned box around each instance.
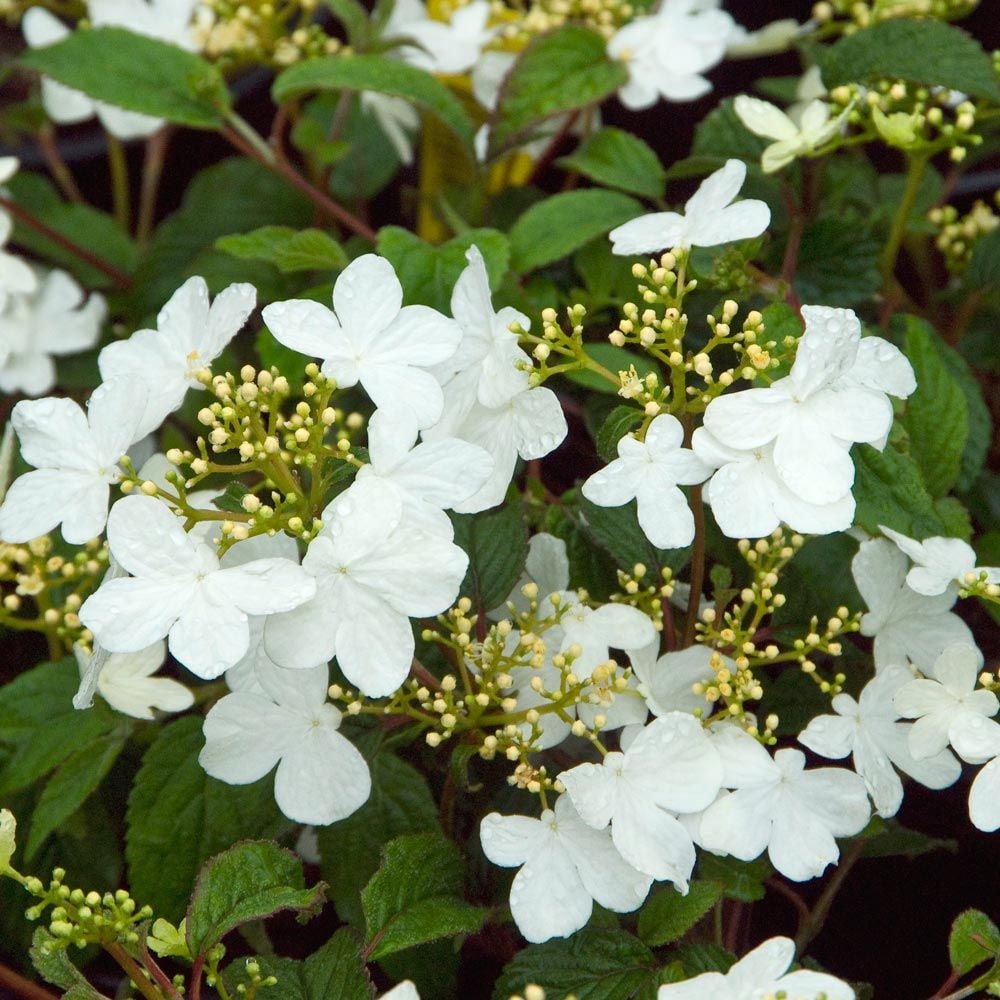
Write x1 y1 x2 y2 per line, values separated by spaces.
608 0 736 111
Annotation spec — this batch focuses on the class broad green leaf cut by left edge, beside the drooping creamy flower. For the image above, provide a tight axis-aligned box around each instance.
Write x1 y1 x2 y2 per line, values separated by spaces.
0 657 117 797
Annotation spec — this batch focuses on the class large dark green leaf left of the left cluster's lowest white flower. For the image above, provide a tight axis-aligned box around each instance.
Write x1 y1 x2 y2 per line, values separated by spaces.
126 713 285 923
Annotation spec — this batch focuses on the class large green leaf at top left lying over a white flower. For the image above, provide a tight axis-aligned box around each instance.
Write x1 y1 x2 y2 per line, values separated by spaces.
20 28 230 129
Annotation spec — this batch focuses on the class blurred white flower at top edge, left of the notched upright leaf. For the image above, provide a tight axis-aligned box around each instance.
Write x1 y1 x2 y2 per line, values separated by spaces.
383 0 495 76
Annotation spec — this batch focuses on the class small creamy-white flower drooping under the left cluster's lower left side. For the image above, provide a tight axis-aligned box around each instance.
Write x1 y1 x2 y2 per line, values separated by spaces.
73 640 194 719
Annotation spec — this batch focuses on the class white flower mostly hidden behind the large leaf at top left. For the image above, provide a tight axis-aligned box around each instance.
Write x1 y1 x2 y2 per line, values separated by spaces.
21 0 195 139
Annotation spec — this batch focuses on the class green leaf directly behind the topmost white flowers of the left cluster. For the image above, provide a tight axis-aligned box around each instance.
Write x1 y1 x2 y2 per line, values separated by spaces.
377 226 510 314
